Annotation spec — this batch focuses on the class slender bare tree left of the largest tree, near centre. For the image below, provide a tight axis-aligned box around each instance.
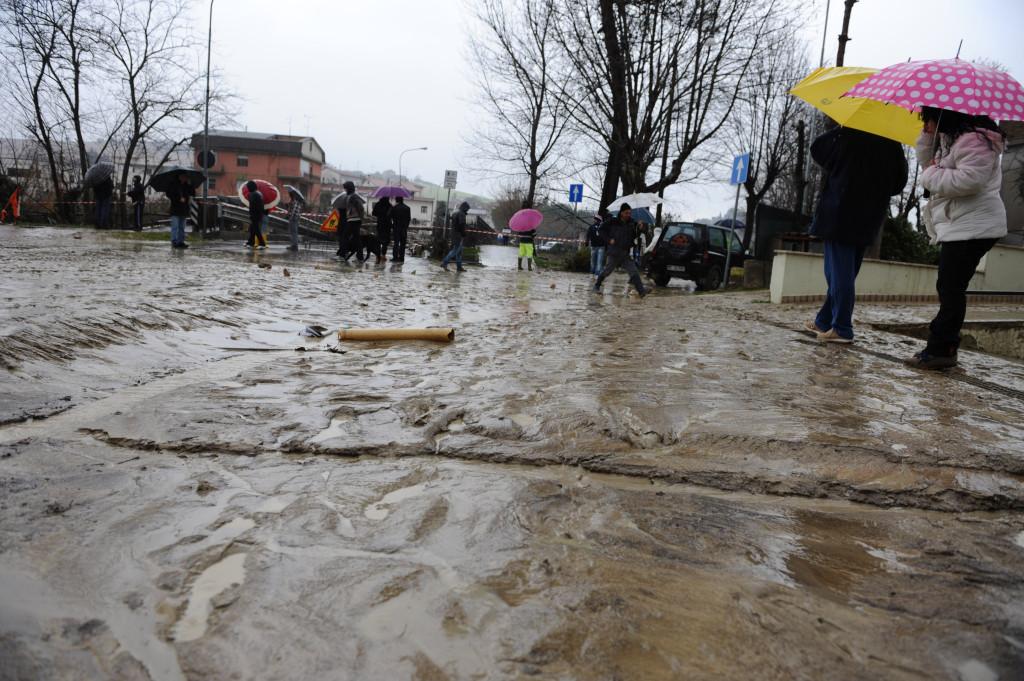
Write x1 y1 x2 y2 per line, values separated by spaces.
468 0 570 205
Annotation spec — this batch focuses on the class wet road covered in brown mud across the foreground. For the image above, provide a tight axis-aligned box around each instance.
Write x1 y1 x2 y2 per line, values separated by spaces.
0 227 1024 681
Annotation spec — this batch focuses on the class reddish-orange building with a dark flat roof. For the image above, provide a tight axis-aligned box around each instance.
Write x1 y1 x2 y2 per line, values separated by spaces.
191 130 325 205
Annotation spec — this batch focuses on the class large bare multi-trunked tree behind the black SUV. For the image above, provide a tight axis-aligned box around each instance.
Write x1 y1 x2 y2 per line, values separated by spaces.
557 0 784 204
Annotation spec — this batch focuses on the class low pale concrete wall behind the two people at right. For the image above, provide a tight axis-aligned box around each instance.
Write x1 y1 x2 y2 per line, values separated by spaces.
771 245 1024 304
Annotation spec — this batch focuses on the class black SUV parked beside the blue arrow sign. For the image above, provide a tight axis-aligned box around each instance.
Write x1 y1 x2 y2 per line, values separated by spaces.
644 222 745 291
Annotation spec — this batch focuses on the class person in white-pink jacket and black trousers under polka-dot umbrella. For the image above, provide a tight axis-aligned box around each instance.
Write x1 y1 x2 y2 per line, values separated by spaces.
906 107 1007 369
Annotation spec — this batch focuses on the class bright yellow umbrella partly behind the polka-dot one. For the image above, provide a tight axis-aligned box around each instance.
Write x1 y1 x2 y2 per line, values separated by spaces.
790 67 921 146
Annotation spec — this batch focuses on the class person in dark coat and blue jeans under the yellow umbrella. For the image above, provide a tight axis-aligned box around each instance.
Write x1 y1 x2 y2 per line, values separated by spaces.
805 127 907 343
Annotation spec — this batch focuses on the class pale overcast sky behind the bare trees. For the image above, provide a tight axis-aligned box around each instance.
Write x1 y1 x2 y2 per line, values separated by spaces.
195 0 1024 219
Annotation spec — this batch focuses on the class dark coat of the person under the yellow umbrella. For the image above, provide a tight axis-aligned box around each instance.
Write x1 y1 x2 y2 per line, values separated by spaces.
810 128 908 247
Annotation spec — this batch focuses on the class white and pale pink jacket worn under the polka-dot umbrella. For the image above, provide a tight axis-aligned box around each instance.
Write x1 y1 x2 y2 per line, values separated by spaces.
918 129 1007 244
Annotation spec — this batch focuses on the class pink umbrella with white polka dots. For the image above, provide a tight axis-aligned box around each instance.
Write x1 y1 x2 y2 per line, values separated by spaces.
843 59 1024 121
